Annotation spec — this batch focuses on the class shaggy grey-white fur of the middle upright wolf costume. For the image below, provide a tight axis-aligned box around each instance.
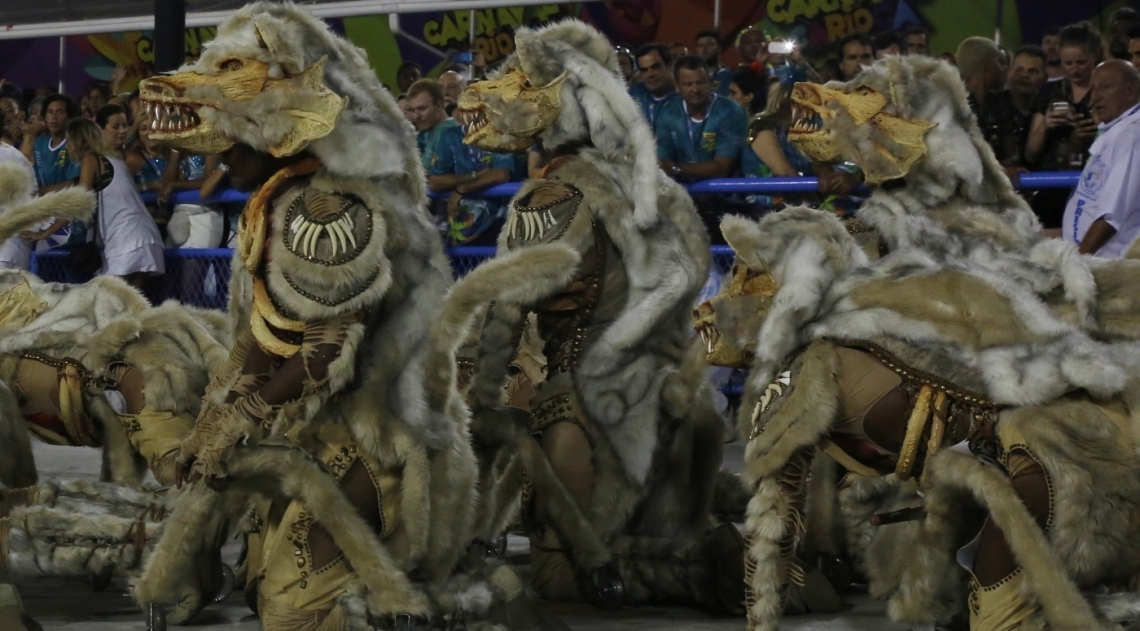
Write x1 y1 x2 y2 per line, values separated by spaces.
463 21 720 603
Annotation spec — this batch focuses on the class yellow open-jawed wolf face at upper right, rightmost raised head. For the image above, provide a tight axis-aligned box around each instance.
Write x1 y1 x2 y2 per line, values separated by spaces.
788 83 937 186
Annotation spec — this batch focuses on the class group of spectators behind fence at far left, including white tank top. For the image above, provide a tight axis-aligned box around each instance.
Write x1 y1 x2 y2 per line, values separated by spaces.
0 68 241 289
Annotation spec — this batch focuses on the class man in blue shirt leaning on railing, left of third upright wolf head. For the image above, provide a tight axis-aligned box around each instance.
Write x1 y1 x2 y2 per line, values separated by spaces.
656 55 748 181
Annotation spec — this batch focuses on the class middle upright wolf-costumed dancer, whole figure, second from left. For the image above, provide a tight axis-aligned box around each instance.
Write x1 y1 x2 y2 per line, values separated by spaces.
455 21 742 612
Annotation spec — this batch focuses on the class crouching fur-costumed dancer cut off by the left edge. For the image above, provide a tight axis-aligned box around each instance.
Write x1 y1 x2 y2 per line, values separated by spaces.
0 154 229 489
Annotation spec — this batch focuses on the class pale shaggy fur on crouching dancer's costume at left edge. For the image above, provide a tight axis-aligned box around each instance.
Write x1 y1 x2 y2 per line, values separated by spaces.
0 271 229 487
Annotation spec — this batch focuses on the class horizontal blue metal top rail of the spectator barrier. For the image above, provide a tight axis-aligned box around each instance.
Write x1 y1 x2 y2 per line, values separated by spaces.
143 171 1081 204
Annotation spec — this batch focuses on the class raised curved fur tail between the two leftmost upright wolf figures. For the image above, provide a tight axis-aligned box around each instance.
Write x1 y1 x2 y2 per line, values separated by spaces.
424 244 581 411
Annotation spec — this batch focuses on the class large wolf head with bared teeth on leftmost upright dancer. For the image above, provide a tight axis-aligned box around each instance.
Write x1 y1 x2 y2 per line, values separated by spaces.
139 2 424 184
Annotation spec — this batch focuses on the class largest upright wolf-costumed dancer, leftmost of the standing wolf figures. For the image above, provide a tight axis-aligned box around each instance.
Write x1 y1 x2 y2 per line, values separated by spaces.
136 2 577 631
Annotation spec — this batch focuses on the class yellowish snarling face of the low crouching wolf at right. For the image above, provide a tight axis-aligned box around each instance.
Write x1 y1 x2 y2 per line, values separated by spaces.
693 256 780 368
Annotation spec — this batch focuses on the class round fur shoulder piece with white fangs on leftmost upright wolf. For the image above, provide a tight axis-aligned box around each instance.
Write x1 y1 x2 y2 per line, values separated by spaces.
267 174 392 320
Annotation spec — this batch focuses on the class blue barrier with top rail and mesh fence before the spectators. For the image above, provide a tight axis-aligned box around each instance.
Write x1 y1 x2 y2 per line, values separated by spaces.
32 172 1080 309
